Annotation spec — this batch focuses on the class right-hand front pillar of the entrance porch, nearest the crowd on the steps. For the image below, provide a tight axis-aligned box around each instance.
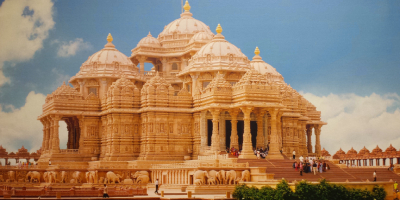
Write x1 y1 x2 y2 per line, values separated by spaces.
267 109 283 159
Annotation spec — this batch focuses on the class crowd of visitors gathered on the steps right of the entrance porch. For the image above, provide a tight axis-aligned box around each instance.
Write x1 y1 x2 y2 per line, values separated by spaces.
293 156 330 176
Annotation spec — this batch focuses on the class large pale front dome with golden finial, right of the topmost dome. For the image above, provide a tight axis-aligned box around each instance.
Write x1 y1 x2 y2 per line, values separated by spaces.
179 24 250 76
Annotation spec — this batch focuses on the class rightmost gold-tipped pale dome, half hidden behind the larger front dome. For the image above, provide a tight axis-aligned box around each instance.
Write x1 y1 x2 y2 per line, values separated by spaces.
250 47 283 81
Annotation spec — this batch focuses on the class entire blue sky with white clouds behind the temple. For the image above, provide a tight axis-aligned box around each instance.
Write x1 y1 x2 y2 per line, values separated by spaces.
0 0 400 155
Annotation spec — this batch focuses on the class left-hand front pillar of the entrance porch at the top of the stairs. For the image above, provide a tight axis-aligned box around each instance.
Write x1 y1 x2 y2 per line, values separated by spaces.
239 107 256 158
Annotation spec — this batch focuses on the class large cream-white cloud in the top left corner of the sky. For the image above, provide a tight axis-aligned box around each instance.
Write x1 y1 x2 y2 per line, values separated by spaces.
0 0 55 86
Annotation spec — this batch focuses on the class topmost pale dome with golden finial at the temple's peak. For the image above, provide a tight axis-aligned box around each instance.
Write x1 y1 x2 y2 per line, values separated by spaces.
158 1 213 41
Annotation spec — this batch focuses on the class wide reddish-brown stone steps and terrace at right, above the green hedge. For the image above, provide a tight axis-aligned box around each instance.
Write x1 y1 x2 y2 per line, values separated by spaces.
238 159 400 182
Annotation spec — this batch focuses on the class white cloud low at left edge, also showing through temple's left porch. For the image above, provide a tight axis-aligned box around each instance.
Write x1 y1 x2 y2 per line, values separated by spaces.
0 91 68 152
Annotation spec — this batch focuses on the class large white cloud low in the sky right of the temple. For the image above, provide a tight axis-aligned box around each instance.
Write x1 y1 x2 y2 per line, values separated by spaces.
302 93 400 155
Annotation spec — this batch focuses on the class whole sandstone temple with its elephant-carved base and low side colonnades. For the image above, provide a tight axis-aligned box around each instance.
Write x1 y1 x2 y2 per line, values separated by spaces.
0 1 400 199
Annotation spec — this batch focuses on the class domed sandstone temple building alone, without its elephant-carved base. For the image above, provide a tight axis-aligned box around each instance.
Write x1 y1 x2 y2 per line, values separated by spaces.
38 0 326 162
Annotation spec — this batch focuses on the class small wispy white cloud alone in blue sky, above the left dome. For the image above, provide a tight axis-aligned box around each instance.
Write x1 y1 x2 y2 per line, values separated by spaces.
54 38 91 57
